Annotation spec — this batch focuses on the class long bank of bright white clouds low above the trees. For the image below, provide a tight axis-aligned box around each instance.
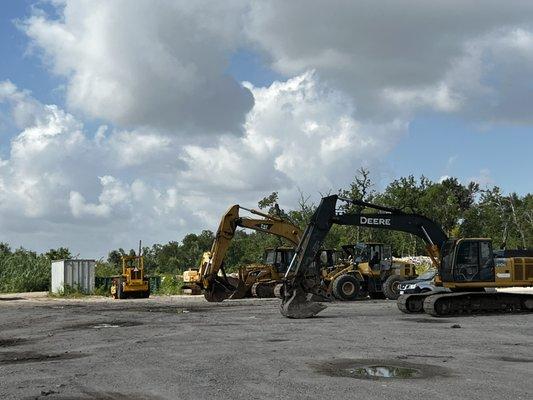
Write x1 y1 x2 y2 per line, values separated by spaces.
0 71 407 253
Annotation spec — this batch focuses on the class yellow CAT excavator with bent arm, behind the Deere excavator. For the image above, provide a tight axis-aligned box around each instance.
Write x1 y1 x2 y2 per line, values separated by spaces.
183 204 301 302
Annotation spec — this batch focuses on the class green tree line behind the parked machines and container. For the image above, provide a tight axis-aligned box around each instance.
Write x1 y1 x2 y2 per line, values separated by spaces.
0 168 533 292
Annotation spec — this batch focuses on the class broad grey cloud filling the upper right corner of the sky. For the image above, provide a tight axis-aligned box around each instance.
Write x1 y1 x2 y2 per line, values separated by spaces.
246 0 533 122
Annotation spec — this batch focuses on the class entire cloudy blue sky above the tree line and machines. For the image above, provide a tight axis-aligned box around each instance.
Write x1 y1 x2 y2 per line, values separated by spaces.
0 0 533 258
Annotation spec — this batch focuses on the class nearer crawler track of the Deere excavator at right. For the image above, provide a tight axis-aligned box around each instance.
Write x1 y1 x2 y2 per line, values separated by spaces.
423 292 533 317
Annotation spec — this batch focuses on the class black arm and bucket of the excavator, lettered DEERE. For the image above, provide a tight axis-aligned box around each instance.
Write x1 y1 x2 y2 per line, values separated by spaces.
281 195 448 318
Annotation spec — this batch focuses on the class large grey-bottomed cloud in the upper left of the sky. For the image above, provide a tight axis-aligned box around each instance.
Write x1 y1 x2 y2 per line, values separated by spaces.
22 0 253 133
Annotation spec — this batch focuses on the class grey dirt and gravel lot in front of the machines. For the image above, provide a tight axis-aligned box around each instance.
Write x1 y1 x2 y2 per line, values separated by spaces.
0 295 533 400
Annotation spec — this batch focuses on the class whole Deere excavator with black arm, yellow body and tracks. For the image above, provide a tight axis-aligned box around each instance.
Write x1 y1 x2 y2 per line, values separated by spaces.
276 195 533 318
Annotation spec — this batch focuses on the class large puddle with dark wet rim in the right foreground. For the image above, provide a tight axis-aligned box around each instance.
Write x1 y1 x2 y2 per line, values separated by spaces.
313 359 450 380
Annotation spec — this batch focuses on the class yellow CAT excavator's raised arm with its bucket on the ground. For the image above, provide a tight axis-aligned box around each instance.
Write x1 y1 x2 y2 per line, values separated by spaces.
199 204 301 301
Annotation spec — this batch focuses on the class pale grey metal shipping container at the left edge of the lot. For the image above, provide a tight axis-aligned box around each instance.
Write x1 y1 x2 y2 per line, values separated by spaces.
50 260 95 293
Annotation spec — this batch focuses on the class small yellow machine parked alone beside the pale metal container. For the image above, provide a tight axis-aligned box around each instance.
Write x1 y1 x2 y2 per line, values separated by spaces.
111 242 150 299
